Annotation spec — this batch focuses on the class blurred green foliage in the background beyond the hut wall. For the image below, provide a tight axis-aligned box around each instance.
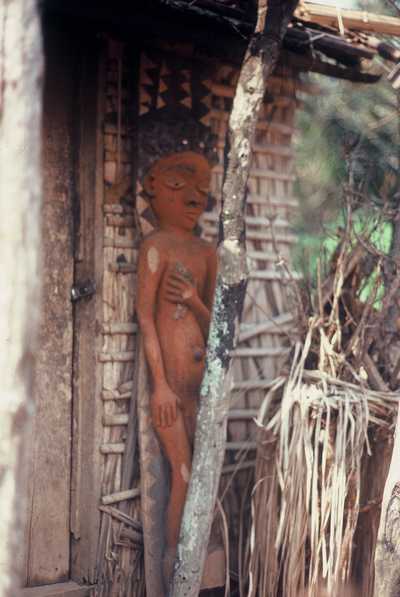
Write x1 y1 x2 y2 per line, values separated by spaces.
293 70 399 286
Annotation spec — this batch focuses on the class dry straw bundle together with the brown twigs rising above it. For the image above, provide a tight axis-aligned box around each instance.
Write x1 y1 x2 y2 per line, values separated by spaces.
248 204 399 597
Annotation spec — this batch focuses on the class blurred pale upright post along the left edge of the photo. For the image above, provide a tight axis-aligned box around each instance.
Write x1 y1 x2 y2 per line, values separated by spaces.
0 0 42 597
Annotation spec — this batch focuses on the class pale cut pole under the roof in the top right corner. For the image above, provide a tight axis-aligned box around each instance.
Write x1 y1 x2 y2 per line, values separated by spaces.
295 2 400 36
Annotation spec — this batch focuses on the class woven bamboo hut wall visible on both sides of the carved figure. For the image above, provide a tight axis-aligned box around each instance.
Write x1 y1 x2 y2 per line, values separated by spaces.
95 42 296 597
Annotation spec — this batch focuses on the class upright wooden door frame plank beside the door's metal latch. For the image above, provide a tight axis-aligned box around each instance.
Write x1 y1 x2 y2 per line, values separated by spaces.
70 32 105 584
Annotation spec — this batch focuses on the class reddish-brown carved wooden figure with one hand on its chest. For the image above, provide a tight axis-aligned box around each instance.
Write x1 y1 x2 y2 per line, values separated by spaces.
137 151 217 586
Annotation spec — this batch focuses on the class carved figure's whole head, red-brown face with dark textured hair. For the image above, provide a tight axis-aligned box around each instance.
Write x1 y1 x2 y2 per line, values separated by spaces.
138 110 218 230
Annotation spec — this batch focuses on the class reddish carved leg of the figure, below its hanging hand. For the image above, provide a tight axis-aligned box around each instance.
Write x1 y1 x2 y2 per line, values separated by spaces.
156 410 192 583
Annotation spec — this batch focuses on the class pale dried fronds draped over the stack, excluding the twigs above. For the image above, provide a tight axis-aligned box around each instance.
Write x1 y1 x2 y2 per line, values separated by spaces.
249 325 398 597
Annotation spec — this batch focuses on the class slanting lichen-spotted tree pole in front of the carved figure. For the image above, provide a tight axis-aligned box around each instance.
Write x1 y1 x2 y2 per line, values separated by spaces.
170 0 297 597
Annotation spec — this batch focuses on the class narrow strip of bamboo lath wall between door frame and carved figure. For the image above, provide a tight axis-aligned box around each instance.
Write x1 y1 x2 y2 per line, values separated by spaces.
95 41 144 597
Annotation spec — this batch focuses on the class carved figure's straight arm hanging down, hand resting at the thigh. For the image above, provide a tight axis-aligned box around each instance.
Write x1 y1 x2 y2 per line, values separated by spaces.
136 239 179 427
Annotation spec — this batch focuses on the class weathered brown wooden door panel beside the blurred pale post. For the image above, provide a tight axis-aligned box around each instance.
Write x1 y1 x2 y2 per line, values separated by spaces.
20 24 81 586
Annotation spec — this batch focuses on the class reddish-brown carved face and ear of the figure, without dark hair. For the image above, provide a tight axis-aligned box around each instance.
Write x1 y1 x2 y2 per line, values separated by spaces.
144 151 211 230
